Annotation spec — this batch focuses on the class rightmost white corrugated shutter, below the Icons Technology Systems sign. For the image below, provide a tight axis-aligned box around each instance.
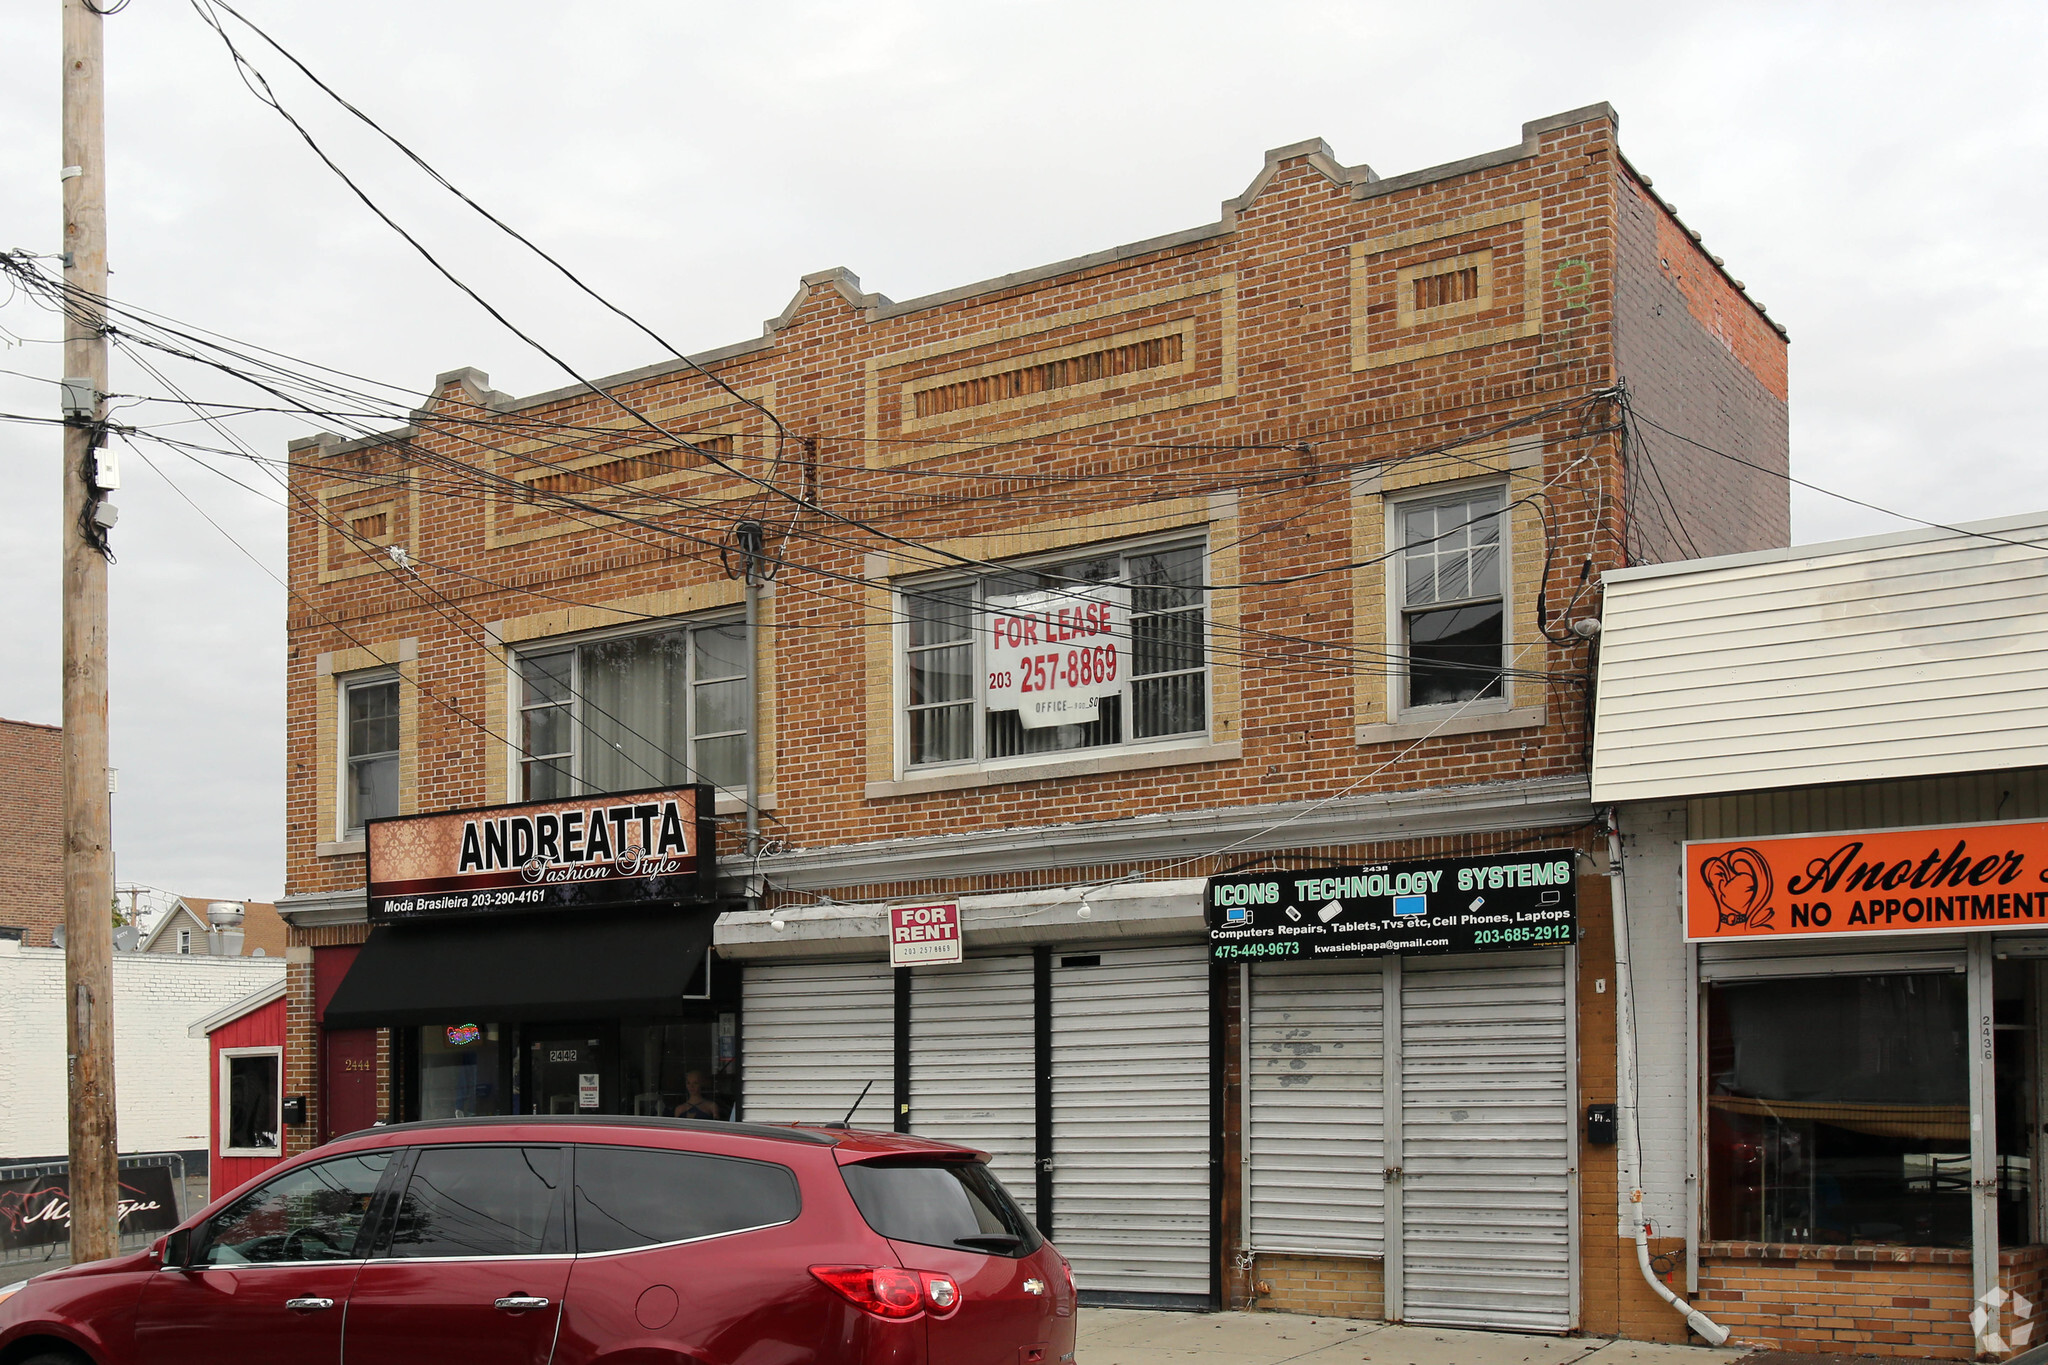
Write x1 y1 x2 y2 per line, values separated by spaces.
1401 954 1575 1332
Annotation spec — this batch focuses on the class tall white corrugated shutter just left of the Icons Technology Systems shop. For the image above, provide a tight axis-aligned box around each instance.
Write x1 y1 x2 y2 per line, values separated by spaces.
1053 943 1212 1308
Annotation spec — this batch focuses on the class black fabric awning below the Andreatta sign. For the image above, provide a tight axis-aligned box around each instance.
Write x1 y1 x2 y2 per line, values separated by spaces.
322 909 717 1029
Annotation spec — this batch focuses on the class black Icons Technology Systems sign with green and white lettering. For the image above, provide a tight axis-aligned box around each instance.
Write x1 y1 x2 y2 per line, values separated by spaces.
1204 849 1579 962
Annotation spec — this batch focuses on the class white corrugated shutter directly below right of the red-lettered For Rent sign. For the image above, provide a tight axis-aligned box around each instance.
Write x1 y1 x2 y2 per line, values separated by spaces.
909 958 1038 1214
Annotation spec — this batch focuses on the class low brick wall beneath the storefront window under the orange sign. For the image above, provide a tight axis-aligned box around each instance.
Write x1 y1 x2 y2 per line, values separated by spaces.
1700 1242 1974 1361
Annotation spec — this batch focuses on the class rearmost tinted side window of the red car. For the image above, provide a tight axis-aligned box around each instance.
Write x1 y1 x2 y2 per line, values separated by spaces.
575 1146 803 1252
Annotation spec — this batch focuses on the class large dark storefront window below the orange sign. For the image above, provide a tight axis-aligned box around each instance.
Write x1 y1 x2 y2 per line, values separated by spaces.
1706 972 1970 1246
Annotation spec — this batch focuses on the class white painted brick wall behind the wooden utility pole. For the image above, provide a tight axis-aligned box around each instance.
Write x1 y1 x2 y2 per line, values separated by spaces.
0 939 285 1158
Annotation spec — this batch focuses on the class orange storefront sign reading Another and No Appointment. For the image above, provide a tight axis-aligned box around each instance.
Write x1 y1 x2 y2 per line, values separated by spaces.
1686 821 2048 941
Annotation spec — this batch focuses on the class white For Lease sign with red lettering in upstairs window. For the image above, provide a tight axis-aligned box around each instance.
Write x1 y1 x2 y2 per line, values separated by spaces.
985 583 1130 731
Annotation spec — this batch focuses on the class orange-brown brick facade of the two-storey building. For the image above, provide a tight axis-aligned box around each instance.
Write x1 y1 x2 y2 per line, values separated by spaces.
287 111 1786 1332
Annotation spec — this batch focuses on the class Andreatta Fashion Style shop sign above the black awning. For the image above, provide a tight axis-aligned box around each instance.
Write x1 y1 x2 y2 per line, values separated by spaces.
367 786 715 923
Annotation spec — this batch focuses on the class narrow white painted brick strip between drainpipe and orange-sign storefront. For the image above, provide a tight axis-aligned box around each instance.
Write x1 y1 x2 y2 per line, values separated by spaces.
1620 802 1692 1236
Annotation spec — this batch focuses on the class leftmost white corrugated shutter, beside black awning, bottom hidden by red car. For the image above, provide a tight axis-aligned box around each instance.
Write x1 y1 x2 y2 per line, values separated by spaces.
739 962 895 1130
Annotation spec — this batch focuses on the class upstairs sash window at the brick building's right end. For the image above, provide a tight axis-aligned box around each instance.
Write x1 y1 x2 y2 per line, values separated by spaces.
1393 487 1507 706
